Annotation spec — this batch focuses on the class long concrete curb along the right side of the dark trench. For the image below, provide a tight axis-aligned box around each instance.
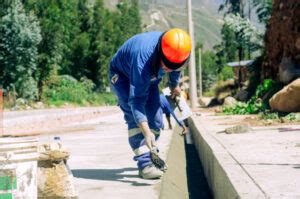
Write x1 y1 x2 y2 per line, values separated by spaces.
189 116 266 199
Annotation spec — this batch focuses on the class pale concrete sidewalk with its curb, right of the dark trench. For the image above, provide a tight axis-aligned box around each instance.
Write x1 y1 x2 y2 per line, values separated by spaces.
189 112 300 199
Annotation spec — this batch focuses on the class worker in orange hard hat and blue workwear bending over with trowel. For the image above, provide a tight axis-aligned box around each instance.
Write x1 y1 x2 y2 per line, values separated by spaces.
109 28 191 179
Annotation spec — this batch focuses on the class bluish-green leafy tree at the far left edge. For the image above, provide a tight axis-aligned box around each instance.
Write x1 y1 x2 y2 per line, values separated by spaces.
0 0 42 100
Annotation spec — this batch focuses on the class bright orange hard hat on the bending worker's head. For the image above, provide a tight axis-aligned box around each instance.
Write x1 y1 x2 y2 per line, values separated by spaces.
161 28 192 69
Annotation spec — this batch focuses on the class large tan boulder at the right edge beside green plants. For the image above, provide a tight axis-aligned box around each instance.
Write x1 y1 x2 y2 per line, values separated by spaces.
269 78 300 112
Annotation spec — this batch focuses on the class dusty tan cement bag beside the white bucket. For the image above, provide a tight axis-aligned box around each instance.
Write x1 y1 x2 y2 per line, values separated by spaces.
37 145 77 199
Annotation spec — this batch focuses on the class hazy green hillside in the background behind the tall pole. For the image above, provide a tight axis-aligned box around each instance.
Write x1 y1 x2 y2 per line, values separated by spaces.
140 0 222 49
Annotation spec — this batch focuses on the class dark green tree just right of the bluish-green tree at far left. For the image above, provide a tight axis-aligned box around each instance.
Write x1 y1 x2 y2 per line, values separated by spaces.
25 0 79 96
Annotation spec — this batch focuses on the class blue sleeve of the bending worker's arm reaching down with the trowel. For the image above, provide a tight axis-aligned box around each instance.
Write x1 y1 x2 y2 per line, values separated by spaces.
128 52 151 124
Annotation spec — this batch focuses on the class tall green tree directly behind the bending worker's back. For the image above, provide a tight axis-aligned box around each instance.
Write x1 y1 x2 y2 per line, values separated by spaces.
86 0 140 91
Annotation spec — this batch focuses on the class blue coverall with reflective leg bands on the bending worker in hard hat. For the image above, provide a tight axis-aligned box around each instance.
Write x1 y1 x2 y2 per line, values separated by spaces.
109 32 180 169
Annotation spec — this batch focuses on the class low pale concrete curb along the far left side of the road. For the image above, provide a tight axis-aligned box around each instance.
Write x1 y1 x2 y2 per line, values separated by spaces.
3 106 117 136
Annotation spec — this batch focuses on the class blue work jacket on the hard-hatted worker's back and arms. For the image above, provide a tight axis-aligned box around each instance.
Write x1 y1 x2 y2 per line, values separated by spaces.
110 32 180 124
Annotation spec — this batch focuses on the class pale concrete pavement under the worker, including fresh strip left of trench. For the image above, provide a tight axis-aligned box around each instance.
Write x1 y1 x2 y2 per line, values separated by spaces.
4 107 189 199
